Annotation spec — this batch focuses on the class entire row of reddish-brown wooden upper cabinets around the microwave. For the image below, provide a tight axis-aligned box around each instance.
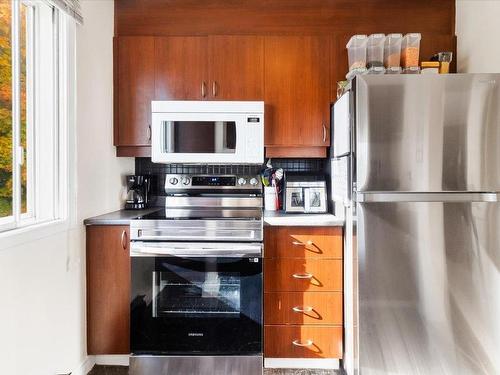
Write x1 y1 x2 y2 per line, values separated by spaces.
115 35 331 157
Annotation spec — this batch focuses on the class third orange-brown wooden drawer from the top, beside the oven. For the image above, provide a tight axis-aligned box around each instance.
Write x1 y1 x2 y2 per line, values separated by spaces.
264 292 343 325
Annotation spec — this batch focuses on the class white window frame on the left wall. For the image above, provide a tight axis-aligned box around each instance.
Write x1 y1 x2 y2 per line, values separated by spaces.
0 0 75 238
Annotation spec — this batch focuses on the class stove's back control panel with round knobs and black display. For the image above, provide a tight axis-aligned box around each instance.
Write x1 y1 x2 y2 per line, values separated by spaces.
165 174 262 192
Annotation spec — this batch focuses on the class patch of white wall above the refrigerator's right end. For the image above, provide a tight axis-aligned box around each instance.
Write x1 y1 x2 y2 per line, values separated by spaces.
456 0 500 73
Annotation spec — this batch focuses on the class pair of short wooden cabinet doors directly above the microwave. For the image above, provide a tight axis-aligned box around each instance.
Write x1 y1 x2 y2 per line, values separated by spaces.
154 35 264 100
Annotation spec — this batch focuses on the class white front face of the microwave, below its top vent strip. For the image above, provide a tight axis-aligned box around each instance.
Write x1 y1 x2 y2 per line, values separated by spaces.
152 112 264 163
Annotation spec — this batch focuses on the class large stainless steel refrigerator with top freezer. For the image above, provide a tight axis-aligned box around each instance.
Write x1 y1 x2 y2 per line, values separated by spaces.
331 74 500 375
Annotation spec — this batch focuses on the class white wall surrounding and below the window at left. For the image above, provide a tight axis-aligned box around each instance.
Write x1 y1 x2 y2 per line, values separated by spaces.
0 0 134 375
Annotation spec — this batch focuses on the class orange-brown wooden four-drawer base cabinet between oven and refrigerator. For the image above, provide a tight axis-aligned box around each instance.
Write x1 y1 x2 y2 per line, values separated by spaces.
264 226 343 359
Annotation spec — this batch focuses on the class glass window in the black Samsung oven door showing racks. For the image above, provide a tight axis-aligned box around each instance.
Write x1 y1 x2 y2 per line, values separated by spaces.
152 265 241 318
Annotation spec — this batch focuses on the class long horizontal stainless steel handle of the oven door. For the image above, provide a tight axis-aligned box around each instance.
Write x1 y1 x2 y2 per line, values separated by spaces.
130 242 262 258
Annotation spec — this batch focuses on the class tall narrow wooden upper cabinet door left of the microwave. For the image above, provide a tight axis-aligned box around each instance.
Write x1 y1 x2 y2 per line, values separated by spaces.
115 36 154 148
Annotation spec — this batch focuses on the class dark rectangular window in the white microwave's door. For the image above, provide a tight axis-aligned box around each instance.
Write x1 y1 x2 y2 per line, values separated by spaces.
164 121 236 154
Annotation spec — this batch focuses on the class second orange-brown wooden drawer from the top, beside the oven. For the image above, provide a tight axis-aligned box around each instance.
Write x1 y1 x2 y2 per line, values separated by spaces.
264 258 342 292
